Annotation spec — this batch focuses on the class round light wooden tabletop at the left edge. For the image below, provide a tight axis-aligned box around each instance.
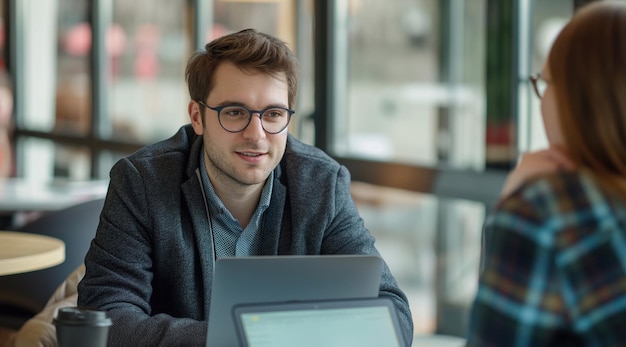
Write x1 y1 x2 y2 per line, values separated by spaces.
0 231 65 276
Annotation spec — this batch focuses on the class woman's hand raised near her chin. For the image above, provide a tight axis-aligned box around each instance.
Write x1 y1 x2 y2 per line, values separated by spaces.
500 146 575 197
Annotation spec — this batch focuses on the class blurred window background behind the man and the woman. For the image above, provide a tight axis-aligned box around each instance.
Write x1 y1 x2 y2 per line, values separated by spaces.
0 0 596 336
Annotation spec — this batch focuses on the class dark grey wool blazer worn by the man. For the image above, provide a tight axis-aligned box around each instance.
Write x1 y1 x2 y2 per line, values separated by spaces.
78 125 413 346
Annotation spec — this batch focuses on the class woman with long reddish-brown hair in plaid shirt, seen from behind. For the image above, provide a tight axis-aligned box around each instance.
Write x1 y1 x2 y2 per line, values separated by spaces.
467 1 626 346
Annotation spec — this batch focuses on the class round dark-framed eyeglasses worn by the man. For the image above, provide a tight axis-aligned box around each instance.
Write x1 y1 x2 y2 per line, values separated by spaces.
196 100 296 134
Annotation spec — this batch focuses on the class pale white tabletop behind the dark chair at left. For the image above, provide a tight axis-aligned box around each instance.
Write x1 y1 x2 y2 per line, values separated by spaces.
0 178 109 214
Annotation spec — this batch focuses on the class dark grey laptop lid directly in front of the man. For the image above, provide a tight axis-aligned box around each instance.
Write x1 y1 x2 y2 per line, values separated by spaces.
206 254 383 347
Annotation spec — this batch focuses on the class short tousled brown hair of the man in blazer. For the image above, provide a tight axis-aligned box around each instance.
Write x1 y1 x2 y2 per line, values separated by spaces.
185 29 300 108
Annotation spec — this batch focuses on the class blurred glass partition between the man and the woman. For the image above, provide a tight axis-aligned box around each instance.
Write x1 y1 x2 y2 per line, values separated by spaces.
328 0 572 336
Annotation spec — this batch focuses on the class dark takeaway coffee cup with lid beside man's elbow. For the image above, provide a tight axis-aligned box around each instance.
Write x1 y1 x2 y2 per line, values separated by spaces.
54 307 111 347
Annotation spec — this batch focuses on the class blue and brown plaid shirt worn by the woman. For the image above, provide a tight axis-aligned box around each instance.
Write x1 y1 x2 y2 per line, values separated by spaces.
467 172 626 347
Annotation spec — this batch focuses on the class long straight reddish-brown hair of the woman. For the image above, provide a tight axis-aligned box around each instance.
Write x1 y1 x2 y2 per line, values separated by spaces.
548 1 626 197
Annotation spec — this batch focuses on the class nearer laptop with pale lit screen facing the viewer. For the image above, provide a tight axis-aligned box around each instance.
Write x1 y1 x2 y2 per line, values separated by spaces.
233 298 406 347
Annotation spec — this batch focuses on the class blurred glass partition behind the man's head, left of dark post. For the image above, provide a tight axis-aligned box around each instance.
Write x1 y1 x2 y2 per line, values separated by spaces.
13 0 313 179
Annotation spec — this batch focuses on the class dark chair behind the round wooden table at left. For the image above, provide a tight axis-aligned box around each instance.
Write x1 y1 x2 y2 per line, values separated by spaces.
0 199 104 330
